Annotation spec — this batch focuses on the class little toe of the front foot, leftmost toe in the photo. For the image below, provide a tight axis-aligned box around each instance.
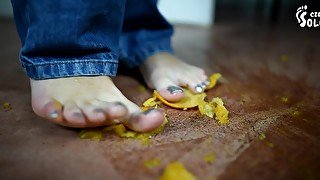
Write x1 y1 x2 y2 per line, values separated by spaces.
43 100 63 123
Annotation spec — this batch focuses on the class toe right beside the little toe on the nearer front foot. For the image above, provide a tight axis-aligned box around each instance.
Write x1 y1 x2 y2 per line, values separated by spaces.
63 103 86 127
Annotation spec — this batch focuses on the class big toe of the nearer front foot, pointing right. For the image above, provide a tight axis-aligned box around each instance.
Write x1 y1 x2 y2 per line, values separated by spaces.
124 109 164 132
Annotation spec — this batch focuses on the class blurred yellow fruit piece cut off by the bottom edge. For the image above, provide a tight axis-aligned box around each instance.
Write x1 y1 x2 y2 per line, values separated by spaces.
160 162 197 180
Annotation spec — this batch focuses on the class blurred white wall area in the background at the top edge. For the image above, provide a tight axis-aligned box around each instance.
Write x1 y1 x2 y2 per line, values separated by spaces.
158 0 215 26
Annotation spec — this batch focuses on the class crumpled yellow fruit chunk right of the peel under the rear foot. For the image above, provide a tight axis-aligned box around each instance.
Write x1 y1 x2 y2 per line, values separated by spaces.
211 97 229 124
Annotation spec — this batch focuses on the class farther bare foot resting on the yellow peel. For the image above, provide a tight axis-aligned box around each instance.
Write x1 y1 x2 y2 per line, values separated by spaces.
140 53 210 102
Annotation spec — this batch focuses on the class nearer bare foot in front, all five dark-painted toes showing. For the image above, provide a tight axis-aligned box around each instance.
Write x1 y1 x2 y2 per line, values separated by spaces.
30 76 164 132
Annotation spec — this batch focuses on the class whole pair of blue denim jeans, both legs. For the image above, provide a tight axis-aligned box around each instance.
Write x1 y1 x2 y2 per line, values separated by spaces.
11 0 173 80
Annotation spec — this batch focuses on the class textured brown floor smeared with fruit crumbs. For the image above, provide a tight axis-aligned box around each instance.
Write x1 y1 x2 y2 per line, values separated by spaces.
0 20 320 179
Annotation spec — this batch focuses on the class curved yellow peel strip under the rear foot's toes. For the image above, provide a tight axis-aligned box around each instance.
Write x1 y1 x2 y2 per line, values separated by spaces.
154 89 206 109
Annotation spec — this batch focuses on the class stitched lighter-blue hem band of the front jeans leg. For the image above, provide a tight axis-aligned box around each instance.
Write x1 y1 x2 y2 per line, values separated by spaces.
22 59 118 80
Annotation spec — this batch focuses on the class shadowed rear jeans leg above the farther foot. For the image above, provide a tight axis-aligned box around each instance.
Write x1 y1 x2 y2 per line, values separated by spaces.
120 0 173 67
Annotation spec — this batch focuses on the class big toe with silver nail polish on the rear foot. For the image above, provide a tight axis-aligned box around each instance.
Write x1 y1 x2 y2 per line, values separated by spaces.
155 79 185 102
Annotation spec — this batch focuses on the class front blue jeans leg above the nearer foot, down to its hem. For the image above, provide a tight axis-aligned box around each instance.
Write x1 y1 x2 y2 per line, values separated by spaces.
11 0 125 79
